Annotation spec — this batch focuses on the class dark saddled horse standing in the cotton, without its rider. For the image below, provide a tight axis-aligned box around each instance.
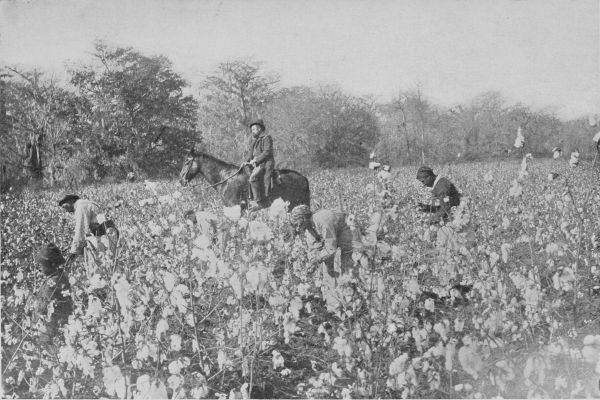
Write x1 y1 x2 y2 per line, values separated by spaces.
179 149 310 211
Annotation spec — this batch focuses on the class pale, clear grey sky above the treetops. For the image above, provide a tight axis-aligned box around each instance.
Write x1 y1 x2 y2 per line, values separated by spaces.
0 0 600 119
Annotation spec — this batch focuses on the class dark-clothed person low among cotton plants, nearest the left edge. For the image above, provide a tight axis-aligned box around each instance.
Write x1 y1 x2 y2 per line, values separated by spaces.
32 243 73 343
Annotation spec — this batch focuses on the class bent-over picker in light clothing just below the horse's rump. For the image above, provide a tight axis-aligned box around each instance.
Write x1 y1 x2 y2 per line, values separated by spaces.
290 205 353 278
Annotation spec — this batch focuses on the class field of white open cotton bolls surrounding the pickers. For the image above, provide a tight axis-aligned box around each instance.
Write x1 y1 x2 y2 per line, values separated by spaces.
0 158 600 398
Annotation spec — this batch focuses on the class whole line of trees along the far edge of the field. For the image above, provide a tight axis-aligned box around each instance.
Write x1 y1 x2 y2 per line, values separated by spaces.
0 42 595 185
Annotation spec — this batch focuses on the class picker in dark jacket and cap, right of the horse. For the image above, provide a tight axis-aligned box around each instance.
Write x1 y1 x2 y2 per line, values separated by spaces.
417 166 460 224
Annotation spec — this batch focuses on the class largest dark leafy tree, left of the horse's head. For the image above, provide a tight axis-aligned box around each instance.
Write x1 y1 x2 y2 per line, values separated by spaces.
70 42 197 175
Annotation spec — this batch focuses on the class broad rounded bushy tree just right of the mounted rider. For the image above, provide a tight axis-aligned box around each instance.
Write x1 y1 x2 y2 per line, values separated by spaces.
265 86 379 168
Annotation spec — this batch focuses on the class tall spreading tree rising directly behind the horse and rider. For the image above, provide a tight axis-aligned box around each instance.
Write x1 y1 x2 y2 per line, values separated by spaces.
198 60 279 160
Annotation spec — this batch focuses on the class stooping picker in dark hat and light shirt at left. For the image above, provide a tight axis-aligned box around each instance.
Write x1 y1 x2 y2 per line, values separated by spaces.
58 194 118 263
